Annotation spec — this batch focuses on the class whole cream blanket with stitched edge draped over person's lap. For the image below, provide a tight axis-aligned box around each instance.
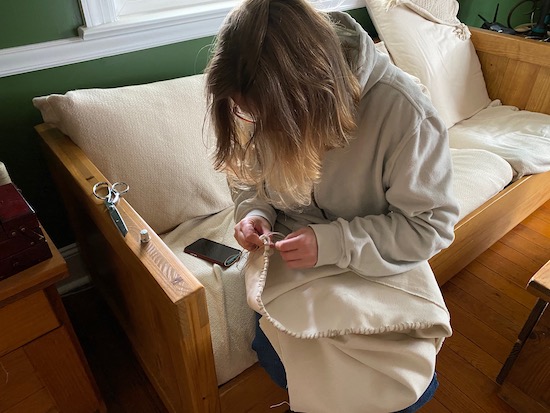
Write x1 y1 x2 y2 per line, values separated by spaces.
245 243 451 413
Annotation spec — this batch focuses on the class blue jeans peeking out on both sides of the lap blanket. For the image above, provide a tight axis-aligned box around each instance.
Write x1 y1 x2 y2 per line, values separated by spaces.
252 314 439 413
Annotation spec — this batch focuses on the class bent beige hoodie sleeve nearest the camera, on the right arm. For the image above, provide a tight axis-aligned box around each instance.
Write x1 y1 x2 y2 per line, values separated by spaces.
310 117 458 276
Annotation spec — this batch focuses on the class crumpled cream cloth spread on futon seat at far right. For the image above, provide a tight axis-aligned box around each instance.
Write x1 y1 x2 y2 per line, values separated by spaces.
449 100 550 180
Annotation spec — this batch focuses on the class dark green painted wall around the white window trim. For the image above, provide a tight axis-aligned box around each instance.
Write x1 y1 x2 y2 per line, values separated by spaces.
0 0 515 247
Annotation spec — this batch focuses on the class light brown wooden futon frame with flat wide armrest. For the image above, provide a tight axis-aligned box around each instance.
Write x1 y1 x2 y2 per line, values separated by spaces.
36 29 550 413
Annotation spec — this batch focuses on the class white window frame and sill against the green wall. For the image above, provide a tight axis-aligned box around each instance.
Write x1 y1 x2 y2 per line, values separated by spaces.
0 0 365 77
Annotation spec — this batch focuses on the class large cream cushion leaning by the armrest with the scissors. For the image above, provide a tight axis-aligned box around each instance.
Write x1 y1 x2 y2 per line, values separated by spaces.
33 75 233 233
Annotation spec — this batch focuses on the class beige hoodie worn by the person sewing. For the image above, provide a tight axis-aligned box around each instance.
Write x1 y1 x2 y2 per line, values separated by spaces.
235 13 458 277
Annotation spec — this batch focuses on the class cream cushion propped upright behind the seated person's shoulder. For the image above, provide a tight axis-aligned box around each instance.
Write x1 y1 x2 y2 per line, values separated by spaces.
365 0 490 127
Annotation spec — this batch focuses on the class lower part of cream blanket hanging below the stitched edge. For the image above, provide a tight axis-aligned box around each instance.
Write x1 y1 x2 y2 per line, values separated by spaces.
260 318 436 413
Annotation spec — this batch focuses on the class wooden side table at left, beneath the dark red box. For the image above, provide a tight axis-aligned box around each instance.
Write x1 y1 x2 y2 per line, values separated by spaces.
0 232 106 413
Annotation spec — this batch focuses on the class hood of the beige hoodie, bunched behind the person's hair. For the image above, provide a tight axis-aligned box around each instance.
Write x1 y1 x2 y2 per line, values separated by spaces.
328 12 395 96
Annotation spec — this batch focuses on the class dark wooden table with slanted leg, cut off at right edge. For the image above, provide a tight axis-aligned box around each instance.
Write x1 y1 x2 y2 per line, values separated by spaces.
497 261 550 413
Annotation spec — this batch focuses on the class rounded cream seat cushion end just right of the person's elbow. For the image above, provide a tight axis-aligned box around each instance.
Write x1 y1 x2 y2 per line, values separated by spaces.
451 148 514 219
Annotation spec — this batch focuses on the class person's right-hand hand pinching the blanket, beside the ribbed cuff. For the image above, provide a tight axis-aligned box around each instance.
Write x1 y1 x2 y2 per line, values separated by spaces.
275 227 317 268
